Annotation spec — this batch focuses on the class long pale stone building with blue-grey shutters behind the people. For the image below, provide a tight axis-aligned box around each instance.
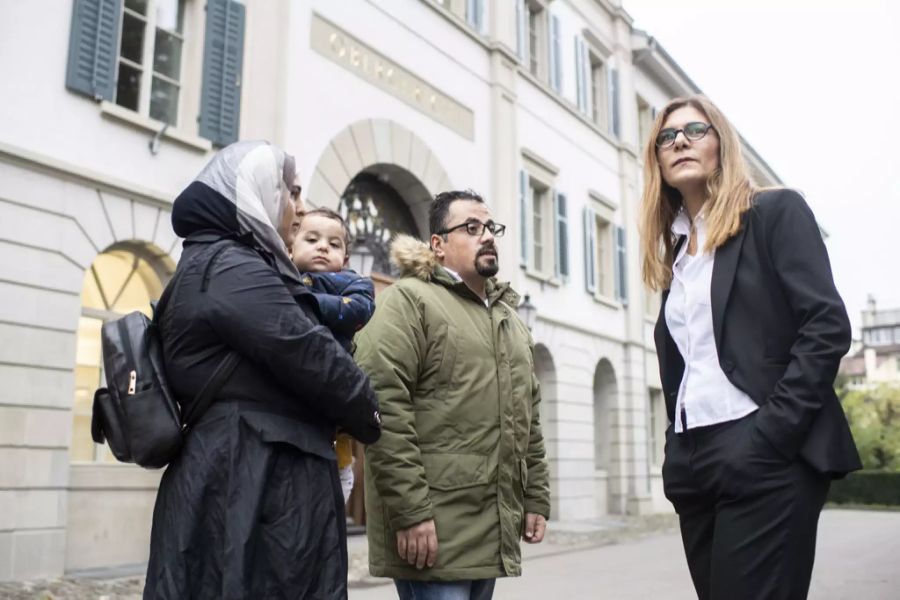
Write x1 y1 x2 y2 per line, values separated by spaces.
0 0 778 580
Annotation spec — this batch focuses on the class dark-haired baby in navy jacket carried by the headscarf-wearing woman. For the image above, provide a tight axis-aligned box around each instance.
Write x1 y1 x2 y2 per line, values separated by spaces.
291 208 375 502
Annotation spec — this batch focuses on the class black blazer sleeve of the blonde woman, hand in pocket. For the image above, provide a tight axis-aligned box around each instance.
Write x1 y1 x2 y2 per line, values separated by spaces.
756 190 850 458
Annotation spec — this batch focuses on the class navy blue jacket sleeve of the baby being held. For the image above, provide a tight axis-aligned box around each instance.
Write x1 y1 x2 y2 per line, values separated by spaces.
309 271 375 338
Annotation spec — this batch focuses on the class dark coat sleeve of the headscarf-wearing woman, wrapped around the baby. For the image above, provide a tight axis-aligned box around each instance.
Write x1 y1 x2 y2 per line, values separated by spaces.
207 247 380 443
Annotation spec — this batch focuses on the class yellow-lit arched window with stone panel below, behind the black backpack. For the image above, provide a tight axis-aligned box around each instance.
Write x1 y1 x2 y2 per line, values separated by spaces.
65 241 175 571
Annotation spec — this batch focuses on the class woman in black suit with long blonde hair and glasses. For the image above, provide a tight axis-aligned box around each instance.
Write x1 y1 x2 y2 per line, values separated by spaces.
641 96 861 600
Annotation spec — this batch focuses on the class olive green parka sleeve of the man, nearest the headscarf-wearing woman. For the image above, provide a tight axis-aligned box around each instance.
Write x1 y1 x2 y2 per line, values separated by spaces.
354 284 434 530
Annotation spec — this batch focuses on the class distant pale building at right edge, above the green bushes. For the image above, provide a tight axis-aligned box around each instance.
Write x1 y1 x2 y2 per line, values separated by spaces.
839 296 900 389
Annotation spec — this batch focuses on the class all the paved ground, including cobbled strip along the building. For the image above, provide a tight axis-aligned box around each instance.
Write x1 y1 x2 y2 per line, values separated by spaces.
0 510 900 600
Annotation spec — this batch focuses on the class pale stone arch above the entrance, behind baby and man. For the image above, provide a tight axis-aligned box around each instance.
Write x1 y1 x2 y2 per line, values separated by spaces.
307 119 451 232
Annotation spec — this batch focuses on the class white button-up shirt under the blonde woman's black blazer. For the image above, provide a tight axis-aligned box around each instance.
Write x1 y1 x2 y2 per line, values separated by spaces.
665 209 758 433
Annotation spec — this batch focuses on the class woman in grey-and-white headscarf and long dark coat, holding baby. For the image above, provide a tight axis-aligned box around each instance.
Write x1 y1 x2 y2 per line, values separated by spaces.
144 142 380 599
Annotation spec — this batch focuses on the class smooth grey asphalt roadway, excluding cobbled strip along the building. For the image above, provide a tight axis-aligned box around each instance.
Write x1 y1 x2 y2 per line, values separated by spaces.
350 510 900 600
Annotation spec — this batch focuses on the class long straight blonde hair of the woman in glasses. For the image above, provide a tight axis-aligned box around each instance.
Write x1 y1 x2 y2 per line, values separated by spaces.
639 95 757 290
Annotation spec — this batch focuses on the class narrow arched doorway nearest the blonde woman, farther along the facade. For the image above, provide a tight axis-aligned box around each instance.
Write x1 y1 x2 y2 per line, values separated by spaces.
594 358 618 515
